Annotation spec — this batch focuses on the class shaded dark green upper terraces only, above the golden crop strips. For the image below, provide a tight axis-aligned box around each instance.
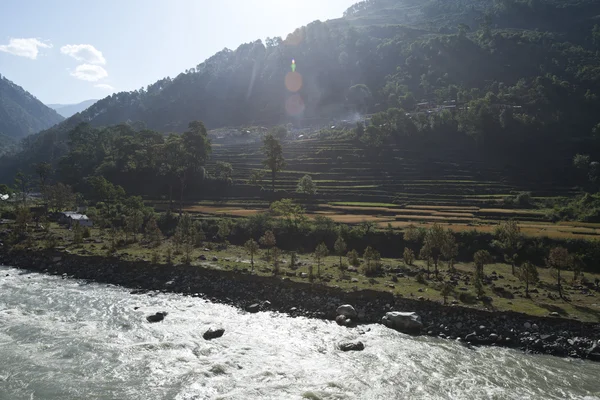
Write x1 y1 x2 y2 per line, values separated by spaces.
208 139 574 208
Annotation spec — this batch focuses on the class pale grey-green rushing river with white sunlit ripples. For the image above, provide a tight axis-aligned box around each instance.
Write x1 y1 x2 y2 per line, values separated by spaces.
0 267 600 400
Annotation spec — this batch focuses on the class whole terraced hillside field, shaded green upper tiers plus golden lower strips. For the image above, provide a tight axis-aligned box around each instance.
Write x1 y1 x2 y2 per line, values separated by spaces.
186 139 600 239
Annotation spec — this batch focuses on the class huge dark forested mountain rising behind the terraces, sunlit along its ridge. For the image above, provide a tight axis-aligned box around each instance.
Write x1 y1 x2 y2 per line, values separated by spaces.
0 0 600 181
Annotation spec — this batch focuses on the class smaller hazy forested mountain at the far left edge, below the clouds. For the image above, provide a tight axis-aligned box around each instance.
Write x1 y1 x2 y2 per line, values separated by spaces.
0 75 64 141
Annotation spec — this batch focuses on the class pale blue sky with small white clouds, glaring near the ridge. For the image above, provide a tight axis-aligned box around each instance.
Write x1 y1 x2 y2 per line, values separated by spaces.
0 0 358 104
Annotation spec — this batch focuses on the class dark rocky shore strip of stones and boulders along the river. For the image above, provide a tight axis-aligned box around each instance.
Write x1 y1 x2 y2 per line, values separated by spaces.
0 250 600 361
